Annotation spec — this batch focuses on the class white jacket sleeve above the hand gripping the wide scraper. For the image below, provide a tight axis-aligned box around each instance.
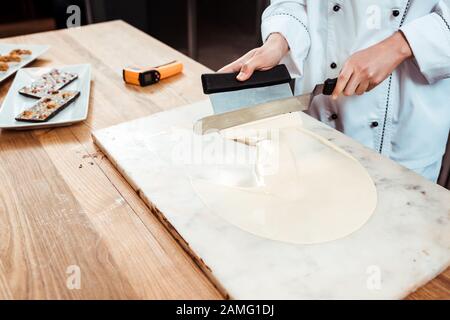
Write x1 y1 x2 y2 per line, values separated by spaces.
261 0 311 77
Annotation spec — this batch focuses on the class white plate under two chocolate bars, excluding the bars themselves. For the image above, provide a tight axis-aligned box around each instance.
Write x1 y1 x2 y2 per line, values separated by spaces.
0 64 91 129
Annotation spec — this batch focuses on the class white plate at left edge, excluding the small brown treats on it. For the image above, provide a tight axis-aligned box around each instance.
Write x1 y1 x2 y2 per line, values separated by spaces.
0 43 50 82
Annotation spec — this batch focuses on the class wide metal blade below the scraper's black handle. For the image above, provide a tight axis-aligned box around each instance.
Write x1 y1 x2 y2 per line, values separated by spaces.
209 83 293 114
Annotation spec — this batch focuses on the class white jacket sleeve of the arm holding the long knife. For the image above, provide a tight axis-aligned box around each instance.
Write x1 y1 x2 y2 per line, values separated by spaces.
400 0 450 83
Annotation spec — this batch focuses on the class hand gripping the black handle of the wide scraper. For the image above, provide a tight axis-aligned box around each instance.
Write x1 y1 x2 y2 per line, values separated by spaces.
218 33 289 81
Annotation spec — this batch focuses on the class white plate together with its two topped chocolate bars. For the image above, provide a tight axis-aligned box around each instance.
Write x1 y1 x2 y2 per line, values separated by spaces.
0 64 91 130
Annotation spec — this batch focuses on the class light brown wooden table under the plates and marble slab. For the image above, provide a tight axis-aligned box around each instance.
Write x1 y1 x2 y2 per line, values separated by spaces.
0 21 450 299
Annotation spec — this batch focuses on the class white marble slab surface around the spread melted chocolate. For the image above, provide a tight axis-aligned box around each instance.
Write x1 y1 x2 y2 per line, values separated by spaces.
94 101 450 299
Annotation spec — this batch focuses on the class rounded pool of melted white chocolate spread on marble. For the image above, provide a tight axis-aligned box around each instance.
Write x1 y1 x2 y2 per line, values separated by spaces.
191 115 377 244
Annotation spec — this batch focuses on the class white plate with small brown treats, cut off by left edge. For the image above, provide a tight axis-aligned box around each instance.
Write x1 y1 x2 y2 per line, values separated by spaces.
0 43 50 82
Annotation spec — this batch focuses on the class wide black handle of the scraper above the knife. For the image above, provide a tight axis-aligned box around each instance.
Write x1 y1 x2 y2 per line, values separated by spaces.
202 64 292 94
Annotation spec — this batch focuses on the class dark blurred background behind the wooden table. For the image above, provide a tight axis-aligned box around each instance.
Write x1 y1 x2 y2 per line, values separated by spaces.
0 0 269 70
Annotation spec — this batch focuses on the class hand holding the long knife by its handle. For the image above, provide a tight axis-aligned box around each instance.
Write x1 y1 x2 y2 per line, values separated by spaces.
332 31 413 100
